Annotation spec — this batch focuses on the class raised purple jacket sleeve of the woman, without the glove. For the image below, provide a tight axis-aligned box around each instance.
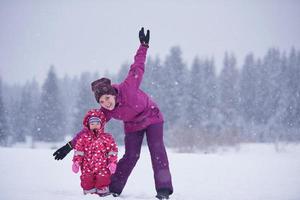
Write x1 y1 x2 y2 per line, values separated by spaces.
122 45 148 89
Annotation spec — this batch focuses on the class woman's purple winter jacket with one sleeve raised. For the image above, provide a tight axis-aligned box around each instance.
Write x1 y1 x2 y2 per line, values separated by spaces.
72 45 163 146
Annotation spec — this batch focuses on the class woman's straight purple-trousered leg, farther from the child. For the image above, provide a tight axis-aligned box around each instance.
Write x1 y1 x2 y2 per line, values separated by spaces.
146 123 173 194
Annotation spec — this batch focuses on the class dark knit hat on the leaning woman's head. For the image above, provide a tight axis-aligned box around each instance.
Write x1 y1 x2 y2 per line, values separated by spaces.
91 78 117 103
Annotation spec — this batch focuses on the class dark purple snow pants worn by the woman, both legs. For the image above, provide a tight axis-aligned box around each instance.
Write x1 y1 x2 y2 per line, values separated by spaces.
109 123 173 194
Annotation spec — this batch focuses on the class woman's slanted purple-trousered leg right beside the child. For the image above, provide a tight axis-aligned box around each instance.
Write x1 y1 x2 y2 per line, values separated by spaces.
109 130 144 194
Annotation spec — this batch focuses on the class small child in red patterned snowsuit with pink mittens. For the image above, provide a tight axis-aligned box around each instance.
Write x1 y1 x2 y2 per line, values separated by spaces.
72 109 118 196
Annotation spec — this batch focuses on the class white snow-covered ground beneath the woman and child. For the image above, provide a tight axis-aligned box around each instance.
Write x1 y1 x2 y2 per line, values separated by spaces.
0 144 300 200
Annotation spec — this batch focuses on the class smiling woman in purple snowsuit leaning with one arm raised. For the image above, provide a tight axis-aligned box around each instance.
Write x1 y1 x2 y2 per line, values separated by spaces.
53 28 173 199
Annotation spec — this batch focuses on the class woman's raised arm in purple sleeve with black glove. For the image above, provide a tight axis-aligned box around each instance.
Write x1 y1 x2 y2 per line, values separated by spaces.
122 28 150 89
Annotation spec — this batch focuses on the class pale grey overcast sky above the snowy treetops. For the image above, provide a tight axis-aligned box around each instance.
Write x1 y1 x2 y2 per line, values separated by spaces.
0 0 300 84
